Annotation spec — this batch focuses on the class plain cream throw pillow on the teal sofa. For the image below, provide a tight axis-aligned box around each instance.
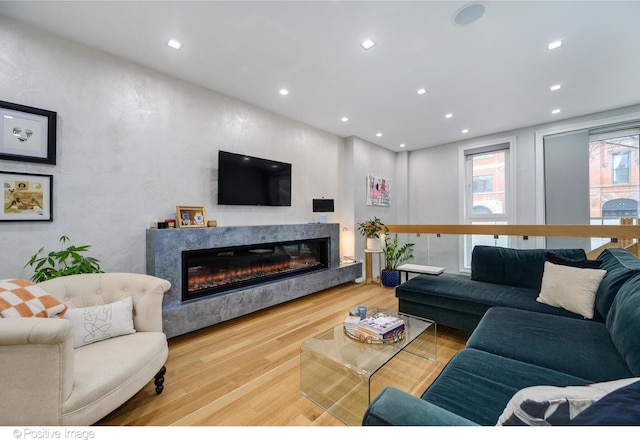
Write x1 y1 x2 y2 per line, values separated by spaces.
536 261 607 319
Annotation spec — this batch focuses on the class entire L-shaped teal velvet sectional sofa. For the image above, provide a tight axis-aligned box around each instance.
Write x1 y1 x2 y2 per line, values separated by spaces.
363 247 640 426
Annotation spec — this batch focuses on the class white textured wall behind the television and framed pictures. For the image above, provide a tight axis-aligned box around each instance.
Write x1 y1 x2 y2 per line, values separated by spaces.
0 17 344 279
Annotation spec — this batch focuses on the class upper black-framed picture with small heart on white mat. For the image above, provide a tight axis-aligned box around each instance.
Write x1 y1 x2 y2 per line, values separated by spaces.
0 101 57 165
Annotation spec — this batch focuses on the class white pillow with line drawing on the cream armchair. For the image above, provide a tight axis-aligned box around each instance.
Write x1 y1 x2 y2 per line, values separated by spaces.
62 296 136 348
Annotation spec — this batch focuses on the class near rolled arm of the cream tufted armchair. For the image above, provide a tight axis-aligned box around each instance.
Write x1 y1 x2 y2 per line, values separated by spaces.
0 318 74 425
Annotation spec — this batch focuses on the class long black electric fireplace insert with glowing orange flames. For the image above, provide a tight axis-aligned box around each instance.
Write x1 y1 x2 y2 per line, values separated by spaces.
182 238 329 301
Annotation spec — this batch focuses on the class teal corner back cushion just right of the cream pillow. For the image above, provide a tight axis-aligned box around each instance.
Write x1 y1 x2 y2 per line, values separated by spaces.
595 248 640 318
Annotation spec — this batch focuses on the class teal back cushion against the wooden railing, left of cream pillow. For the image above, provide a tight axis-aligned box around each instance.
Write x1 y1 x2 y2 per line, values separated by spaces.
471 245 587 290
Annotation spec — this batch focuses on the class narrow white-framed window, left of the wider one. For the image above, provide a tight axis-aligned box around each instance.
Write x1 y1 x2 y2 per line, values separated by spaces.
461 139 513 271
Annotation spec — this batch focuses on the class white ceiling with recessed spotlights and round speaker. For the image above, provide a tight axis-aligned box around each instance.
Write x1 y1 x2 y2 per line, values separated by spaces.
0 1 640 151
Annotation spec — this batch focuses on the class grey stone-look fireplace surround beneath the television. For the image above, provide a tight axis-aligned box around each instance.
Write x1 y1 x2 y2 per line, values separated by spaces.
146 223 362 338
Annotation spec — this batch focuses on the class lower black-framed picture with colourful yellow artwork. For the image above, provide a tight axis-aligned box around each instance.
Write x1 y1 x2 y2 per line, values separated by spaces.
0 171 53 222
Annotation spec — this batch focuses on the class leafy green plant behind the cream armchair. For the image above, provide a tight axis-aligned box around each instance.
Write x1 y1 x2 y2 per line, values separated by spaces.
24 235 103 283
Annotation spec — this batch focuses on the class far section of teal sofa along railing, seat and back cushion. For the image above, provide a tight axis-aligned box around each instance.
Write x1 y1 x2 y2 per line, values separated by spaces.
396 246 608 331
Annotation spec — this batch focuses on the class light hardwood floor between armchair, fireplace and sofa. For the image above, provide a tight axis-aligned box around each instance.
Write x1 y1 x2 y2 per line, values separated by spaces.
97 283 468 426
